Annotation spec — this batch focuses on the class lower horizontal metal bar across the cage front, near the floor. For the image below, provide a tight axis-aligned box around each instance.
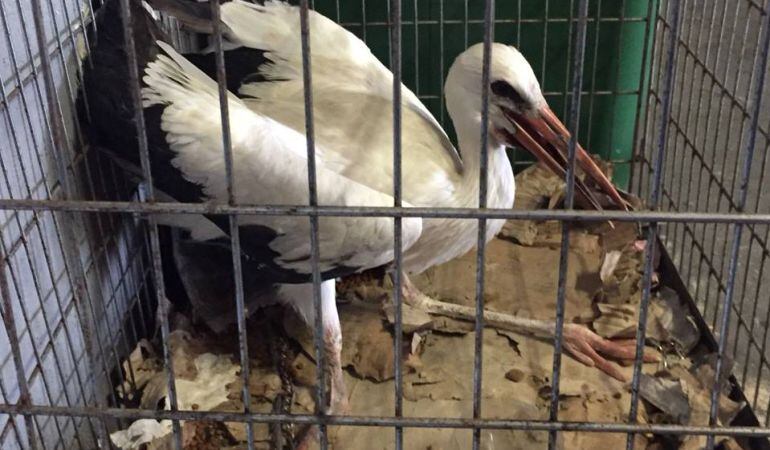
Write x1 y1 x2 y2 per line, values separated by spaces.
0 403 770 437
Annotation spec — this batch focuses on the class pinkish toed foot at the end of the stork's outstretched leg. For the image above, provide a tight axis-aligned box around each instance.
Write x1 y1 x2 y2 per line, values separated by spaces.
563 324 658 382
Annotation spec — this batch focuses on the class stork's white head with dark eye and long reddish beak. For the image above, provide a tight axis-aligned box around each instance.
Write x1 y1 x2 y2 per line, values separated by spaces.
444 43 626 209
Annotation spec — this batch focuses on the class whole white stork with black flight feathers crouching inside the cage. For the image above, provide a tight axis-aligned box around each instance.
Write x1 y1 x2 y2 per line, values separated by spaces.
82 0 648 424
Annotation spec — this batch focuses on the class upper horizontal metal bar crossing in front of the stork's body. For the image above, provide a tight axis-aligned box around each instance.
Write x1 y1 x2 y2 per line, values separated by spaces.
0 199 770 225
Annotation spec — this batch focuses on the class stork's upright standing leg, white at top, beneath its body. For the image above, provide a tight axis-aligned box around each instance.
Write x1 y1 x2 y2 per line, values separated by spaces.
278 280 349 449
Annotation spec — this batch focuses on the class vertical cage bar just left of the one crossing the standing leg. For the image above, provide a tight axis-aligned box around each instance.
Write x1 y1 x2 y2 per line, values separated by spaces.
211 0 255 450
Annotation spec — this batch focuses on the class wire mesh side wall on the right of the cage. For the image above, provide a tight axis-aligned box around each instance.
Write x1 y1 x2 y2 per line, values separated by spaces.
635 1 770 428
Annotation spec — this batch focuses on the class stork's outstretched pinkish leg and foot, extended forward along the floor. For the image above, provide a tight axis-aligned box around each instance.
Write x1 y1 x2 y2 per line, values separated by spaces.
401 273 657 381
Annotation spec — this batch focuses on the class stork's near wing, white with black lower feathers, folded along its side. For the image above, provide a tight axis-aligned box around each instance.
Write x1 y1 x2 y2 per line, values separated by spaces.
143 43 422 282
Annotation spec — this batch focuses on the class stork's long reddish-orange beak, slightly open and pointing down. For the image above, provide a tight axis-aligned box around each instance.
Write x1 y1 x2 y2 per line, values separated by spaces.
499 105 628 211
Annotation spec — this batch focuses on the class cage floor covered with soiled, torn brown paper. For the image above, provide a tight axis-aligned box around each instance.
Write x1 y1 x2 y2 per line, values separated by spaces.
106 168 752 450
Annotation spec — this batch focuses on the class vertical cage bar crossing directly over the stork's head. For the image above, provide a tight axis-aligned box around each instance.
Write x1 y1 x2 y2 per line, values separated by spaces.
473 0 495 450
